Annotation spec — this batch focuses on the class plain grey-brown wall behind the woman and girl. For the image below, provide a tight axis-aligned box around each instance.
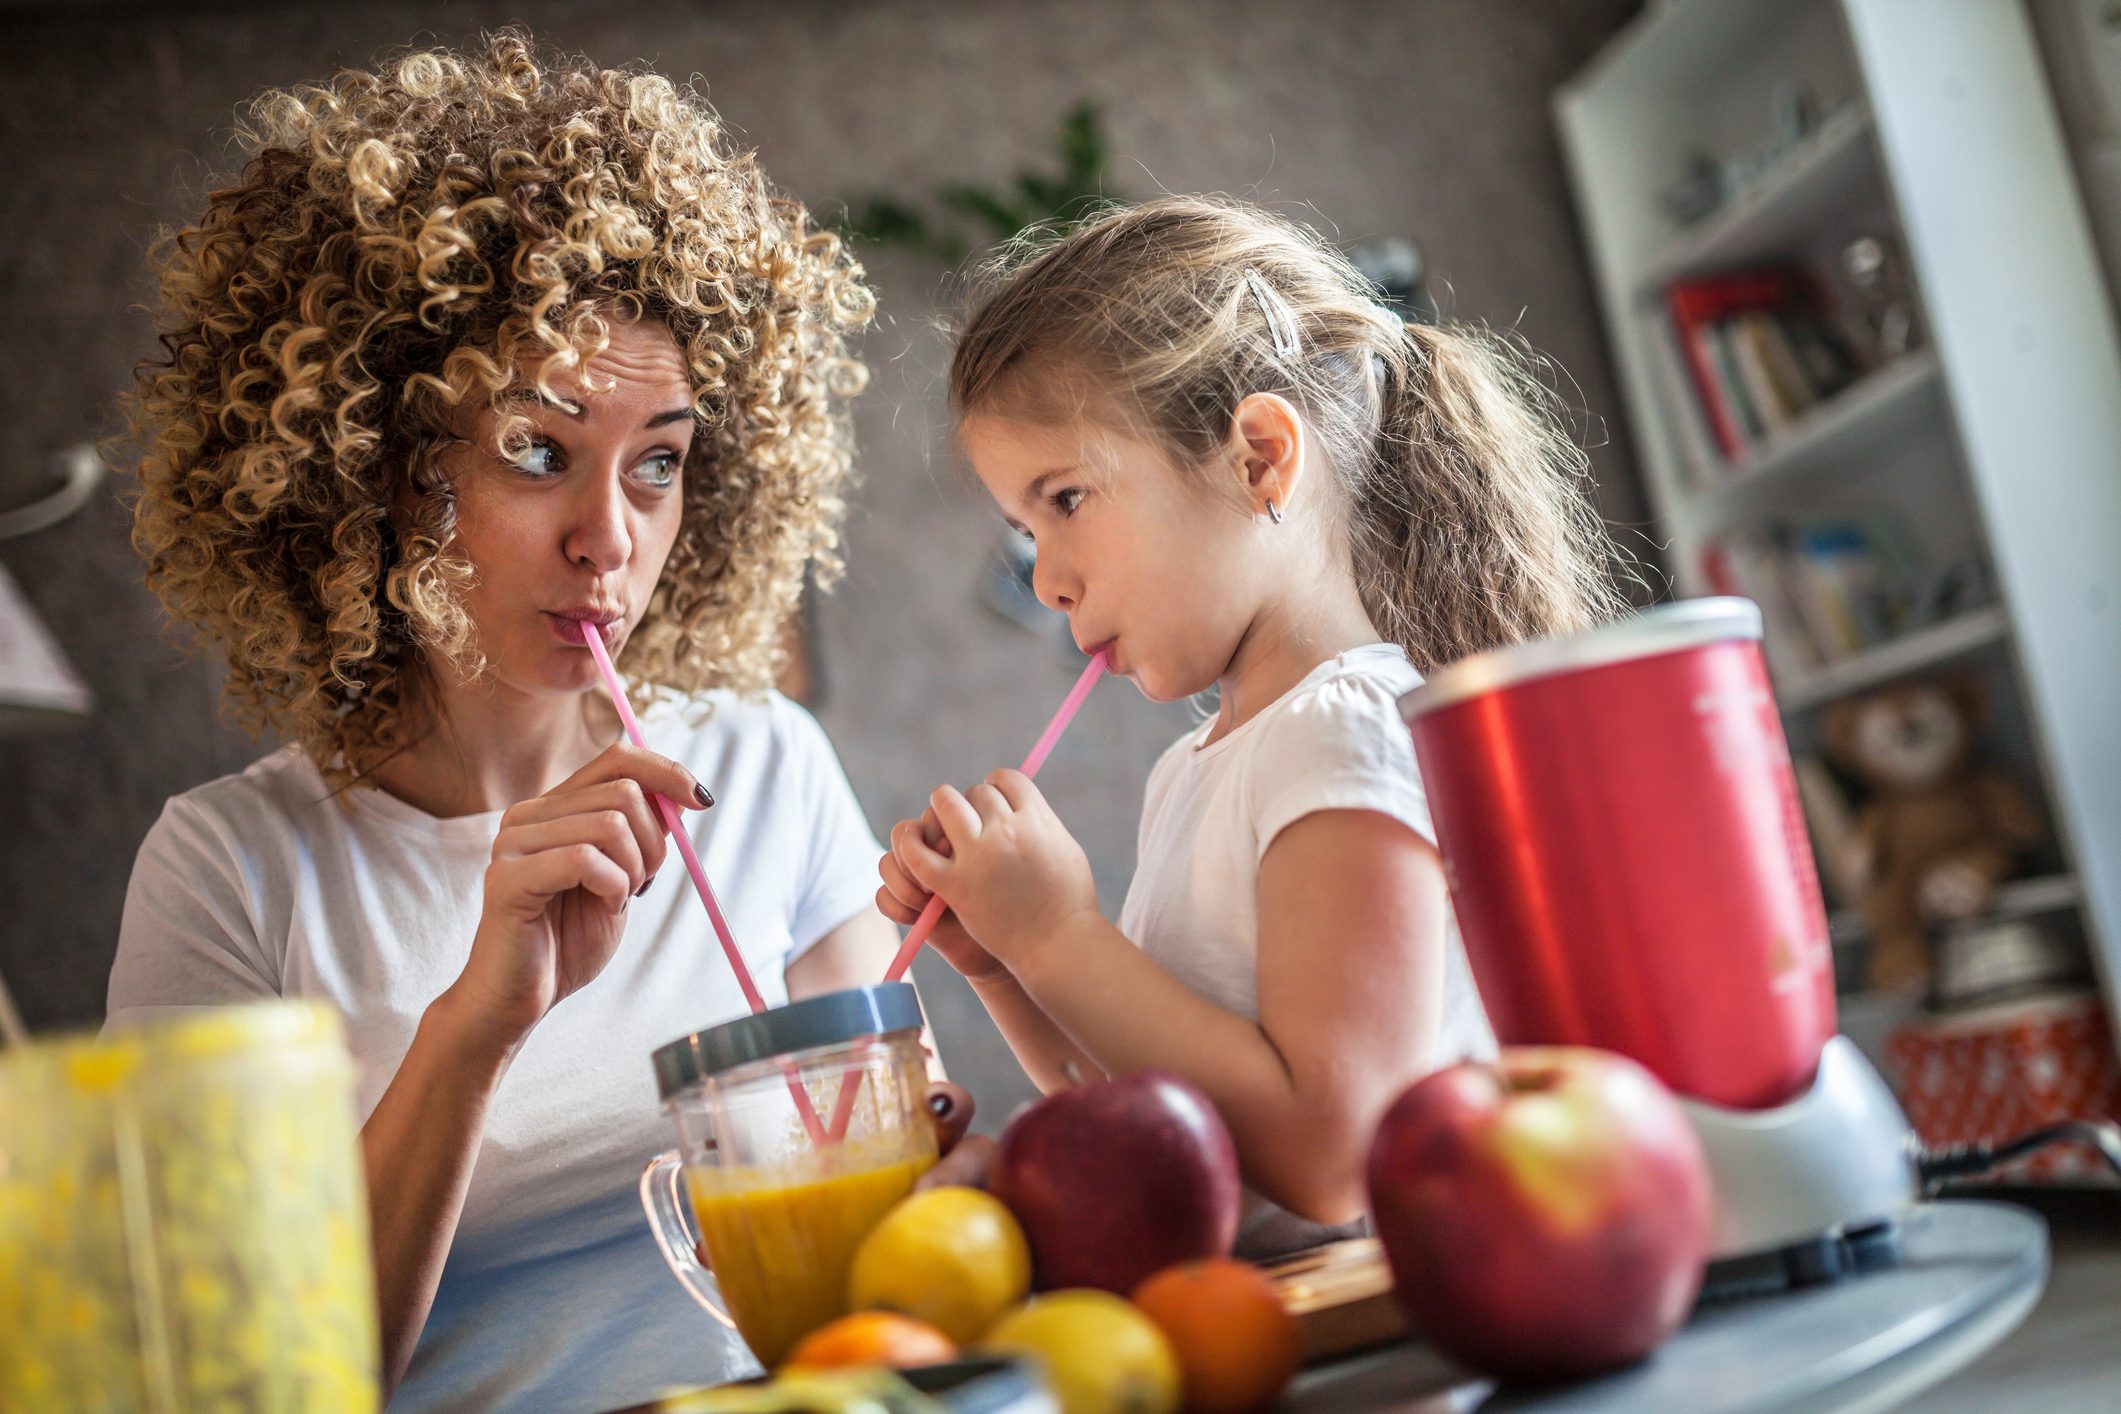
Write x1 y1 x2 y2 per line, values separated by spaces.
0 0 1640 1124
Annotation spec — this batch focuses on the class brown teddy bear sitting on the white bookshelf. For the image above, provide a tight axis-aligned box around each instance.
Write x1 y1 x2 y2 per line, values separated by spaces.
1820 674 2047 990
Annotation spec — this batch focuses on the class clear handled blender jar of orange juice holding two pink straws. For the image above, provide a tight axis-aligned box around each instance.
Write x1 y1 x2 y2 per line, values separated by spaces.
641 982 935 1365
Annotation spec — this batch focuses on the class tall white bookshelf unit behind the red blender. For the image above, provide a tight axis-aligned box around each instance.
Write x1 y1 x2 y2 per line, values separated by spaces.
1555 0 2121 1030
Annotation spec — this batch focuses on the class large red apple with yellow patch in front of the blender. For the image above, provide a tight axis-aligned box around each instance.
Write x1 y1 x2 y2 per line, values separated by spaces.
1368 1047 1710 1380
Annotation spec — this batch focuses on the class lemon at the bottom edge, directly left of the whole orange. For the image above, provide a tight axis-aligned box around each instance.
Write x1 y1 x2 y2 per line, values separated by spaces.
980 1289 1179 1414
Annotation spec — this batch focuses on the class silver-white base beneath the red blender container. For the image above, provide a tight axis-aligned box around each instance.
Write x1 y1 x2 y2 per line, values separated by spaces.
1680 1037 1920 1263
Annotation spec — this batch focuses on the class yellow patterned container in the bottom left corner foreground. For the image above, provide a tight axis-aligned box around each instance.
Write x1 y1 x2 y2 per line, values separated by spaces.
0 1003 380 1414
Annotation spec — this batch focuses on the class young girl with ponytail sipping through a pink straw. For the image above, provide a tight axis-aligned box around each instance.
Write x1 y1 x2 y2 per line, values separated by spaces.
878 197 1618 1257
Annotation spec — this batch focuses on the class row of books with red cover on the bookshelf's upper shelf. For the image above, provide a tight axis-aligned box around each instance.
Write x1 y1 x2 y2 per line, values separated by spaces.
1665 265 1860 466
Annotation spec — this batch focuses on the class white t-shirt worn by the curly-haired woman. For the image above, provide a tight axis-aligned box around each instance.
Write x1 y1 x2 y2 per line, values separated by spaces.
110 693 882 1414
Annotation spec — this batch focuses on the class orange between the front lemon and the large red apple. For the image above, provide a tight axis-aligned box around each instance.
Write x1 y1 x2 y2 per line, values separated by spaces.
1135 1257 1304 1414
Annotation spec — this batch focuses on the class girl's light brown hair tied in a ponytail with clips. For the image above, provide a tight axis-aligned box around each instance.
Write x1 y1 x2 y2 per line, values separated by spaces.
950 197 1627 672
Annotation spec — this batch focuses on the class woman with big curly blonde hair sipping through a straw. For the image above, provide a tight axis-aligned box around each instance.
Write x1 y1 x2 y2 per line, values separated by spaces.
110 34 954 1410
